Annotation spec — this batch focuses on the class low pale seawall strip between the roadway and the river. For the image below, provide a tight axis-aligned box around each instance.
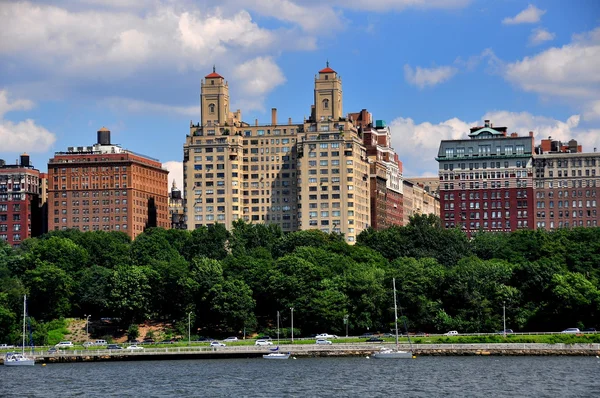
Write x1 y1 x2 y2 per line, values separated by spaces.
2 343 600 363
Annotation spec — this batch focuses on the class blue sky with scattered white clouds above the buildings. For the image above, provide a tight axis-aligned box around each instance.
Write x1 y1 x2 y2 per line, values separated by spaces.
0 0 600 187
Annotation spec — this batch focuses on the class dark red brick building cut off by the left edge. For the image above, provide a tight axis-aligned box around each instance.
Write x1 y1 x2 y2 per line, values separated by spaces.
0 153 45 247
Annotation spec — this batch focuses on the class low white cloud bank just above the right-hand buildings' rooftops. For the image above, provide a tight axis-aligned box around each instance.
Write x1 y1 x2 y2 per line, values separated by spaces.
390 110 600 176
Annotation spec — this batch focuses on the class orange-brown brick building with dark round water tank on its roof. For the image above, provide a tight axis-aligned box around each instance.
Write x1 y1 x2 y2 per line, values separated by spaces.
48 127 171 238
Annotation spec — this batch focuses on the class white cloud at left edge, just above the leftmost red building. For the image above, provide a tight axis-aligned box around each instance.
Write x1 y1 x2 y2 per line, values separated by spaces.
0 90 56 152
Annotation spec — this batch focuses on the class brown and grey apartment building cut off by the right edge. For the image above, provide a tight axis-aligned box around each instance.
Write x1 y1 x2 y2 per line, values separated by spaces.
534 138 600 230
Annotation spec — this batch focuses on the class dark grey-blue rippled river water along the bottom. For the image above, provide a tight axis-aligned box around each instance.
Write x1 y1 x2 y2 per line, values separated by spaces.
0 356 600 398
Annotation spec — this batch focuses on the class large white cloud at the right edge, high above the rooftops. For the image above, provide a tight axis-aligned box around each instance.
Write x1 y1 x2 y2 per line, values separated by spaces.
505 28 600 99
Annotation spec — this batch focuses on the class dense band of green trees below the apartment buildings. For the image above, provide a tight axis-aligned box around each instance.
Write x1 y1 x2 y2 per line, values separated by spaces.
0 216 600 342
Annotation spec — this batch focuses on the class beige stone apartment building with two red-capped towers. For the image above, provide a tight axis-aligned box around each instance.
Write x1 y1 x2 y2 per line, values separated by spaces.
183 67 370 243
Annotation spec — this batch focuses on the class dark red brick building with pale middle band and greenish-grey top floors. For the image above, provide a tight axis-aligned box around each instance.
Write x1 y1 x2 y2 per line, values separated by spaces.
436 120 534 235
